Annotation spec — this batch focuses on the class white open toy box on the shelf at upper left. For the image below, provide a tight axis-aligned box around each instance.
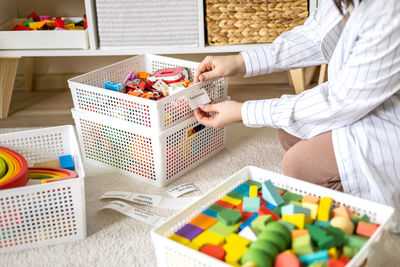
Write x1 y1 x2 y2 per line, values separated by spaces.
0 18 89 49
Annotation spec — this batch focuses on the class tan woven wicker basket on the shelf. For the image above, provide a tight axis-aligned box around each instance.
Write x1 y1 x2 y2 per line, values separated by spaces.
205 0 308 45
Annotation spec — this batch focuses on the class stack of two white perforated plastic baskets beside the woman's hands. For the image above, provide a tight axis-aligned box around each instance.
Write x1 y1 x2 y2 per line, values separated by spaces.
68 54 228 186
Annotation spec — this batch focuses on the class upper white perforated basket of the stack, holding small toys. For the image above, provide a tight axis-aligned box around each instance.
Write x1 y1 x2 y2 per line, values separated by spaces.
68 54 228 131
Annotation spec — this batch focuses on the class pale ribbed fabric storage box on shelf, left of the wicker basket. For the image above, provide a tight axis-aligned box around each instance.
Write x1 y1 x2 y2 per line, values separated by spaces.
96 0 202 49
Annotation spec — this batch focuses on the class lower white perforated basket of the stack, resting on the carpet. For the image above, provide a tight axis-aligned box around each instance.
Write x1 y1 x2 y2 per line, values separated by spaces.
72 110 226 186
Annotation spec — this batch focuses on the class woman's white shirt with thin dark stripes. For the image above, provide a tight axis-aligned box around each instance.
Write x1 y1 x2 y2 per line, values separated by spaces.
241 0 400 232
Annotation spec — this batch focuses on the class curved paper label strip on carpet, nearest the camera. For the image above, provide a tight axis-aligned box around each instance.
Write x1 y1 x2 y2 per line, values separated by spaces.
101 200 166 226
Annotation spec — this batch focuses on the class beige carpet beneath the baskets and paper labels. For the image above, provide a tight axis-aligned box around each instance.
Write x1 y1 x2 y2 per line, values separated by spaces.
0 124 400 266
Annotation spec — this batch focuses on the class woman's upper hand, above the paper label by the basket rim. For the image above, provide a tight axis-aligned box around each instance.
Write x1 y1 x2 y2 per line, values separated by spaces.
194 54 246 83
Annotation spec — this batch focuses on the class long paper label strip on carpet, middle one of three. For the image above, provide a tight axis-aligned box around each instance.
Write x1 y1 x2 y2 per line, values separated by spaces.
100 191 197 209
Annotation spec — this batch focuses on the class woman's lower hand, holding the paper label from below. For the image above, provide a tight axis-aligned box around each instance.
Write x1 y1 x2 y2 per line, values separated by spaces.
194 100 242 129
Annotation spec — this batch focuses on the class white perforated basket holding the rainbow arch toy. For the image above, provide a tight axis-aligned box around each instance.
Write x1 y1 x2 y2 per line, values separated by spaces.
0 126 86 253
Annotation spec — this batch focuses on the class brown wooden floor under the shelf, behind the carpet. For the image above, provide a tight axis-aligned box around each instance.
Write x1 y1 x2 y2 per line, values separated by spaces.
0 84 294 128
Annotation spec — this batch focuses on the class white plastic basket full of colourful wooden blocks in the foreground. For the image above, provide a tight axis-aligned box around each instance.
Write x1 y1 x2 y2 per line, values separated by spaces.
151 166 394 267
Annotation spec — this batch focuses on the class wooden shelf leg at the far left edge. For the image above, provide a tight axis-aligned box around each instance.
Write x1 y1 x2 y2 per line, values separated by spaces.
0 57 20 119
